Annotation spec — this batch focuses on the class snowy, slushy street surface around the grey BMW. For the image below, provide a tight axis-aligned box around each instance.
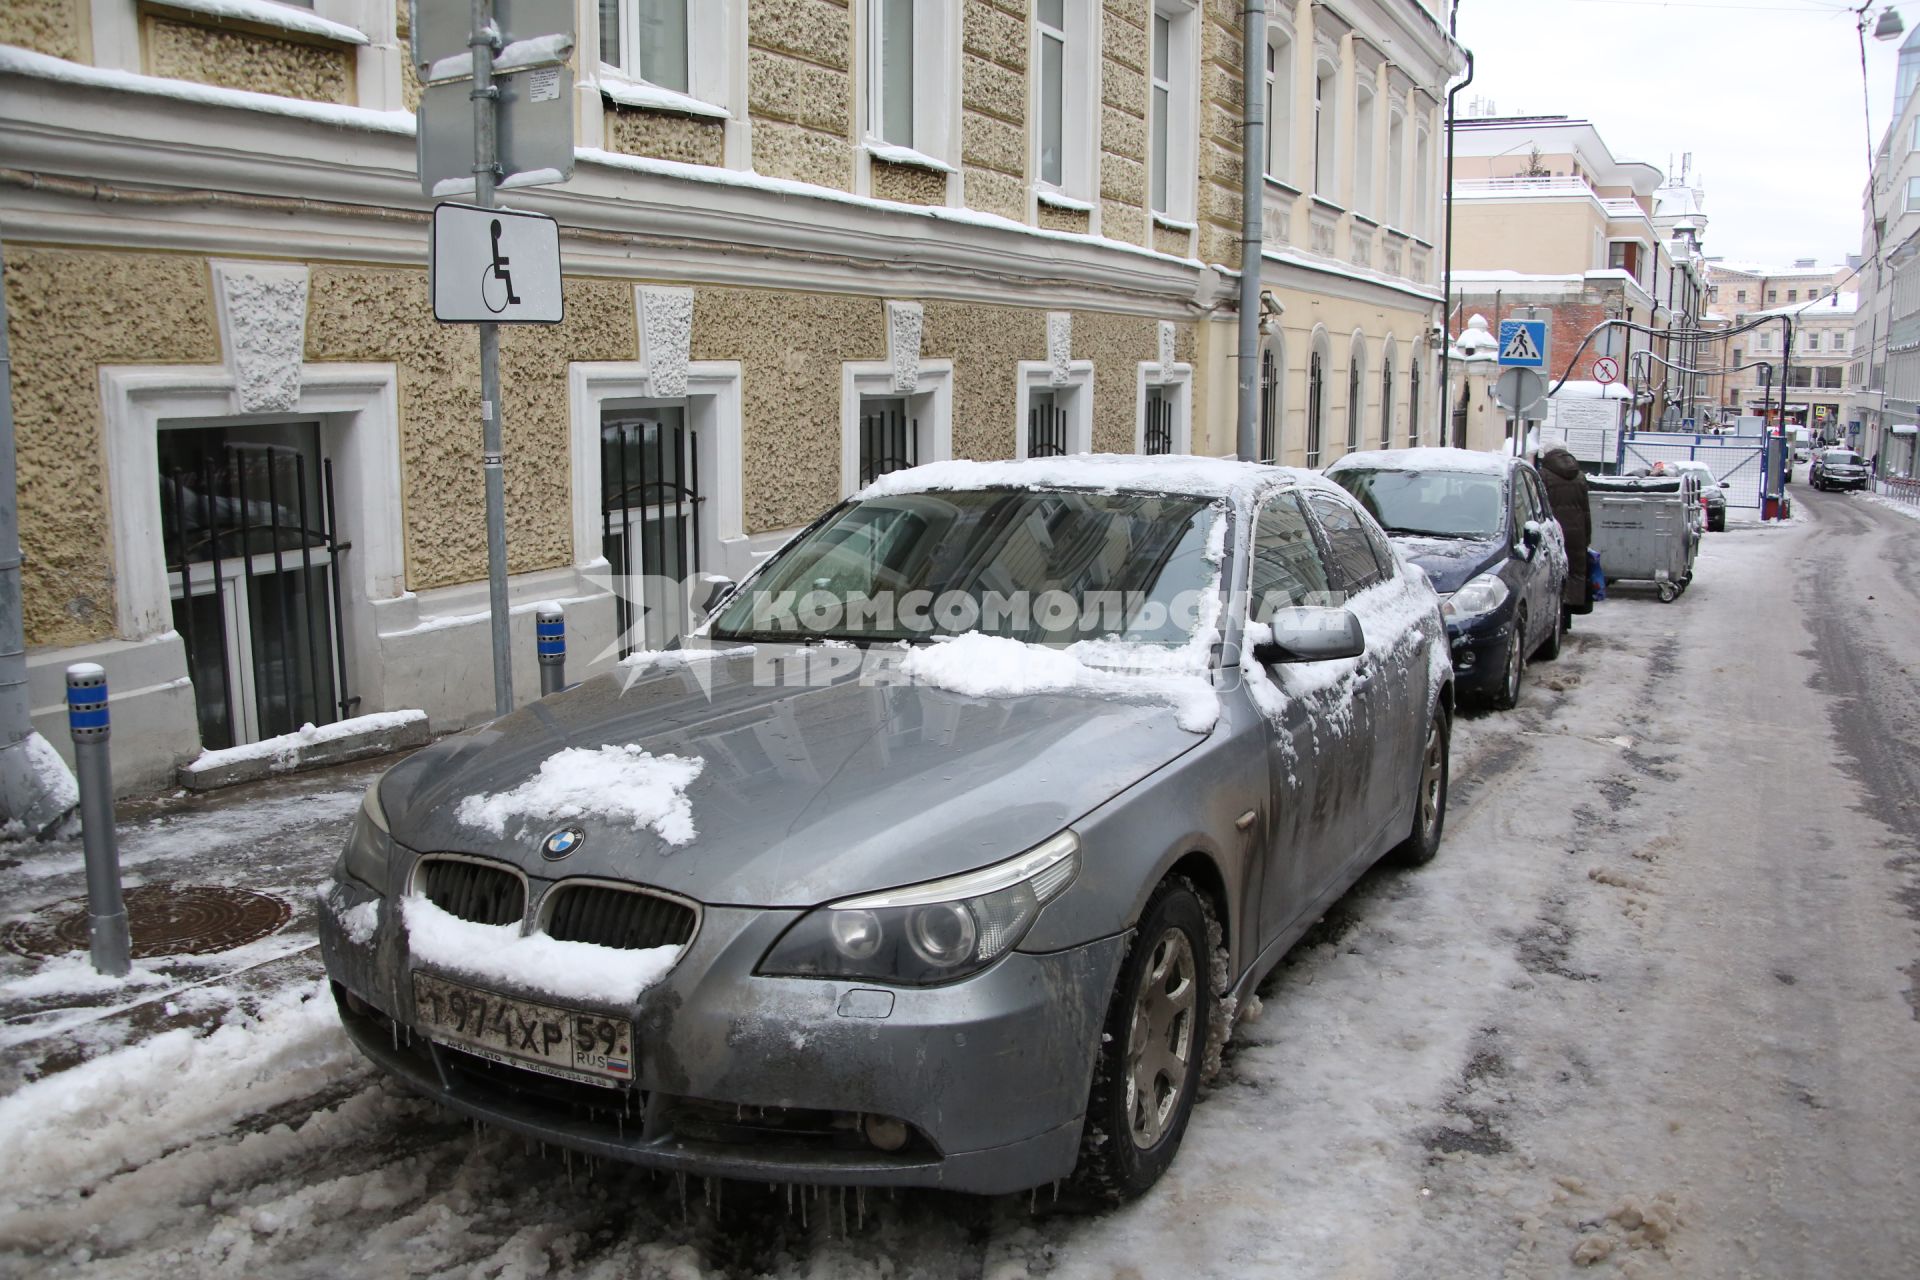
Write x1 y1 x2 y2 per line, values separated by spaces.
0 491 1920 1280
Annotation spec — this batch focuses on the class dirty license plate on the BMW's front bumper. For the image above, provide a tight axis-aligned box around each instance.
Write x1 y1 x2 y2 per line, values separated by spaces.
413 973 634 1086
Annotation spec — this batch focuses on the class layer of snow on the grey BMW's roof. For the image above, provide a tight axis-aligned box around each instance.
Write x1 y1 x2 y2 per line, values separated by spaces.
854 453 1319 499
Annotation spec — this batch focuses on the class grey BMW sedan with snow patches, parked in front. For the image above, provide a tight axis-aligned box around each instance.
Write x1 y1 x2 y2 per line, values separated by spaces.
321 457 1453 1199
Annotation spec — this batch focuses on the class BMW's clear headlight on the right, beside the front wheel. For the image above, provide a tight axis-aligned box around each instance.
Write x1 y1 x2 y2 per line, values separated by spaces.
760 831 1079 986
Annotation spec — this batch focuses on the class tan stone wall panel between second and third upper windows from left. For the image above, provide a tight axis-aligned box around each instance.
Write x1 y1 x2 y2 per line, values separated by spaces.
967 0 1027 223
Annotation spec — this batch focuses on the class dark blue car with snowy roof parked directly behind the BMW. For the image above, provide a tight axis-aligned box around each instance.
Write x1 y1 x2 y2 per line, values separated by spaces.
1327 449 1567 708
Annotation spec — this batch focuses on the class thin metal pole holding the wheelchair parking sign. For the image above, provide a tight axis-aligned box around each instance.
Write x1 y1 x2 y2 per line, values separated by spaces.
467 0 513 716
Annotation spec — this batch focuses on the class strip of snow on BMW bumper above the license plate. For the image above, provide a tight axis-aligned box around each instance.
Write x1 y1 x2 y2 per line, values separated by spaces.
399 896 680 1004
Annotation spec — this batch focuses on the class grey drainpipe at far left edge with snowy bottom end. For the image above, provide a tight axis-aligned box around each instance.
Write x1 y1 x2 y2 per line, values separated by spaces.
0 235 81 837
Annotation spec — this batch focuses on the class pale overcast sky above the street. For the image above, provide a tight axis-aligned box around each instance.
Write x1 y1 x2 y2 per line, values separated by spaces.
1457 0 1896 265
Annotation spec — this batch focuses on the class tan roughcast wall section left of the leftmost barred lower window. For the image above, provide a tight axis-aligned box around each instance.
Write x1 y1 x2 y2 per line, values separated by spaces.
6 244 221 645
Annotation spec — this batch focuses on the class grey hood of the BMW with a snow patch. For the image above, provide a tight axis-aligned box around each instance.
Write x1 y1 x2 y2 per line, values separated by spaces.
380 647 1204 906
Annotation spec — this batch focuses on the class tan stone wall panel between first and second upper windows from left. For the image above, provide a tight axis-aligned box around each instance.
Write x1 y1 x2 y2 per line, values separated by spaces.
747 0 852 192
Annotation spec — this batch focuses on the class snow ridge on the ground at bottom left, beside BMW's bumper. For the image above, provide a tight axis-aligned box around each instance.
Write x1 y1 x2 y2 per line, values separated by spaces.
0 983 357 1205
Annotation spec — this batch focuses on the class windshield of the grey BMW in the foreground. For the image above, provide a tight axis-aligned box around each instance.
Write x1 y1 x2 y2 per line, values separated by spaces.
712 489 1225 647
